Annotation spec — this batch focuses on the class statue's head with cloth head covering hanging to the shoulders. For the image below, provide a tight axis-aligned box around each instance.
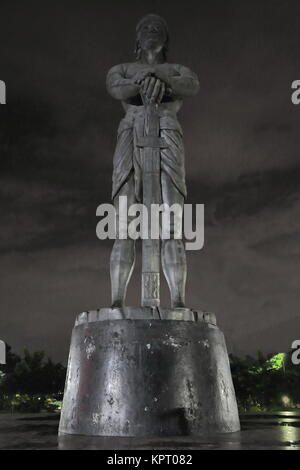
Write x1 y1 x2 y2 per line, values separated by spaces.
135 13 169 60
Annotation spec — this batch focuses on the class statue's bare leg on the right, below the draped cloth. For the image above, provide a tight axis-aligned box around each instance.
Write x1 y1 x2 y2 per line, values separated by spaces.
161 172 187 308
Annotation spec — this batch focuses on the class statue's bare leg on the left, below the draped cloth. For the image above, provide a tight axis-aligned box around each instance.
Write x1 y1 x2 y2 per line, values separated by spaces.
110 173 136 308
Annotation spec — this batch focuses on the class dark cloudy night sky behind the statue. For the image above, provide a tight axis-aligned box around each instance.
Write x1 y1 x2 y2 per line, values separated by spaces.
0 0 300 362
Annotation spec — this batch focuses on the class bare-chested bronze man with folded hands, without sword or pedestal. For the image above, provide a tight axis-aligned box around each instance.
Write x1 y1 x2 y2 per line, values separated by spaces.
107 14 199 308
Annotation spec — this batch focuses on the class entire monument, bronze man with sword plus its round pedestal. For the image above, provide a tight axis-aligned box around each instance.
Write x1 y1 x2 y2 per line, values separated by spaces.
59 15 240 440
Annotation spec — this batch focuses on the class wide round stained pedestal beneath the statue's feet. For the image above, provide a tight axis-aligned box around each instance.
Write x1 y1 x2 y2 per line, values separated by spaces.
59 307 240 437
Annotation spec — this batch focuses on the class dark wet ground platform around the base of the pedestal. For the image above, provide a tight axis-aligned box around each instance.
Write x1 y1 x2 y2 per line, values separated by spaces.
0 411 300 450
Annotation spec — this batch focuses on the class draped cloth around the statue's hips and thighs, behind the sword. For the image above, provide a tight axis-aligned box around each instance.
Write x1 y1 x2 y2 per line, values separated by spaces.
112 106 186 201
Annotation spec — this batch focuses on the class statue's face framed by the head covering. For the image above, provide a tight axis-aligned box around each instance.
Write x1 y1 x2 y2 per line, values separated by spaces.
138 20 167 52
